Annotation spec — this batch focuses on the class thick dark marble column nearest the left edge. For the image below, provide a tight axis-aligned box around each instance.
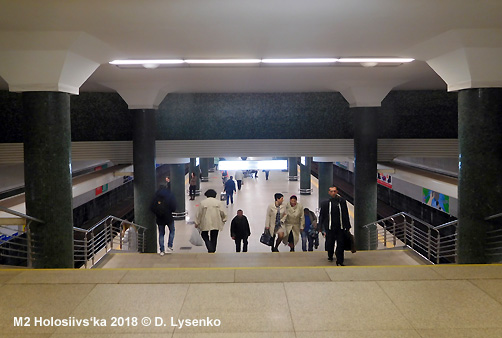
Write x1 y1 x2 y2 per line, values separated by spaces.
22 92 74 268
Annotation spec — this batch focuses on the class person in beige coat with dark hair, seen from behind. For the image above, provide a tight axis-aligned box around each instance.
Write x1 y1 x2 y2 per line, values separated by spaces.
195 189 227 253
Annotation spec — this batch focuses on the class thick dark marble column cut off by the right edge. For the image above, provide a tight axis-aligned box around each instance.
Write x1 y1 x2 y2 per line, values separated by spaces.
457 88 502 264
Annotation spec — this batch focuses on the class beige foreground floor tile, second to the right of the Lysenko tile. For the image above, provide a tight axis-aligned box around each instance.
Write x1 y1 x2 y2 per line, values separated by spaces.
377 280 502 329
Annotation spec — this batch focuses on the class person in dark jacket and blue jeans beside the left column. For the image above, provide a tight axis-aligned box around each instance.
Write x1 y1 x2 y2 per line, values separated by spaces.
150 186 176 256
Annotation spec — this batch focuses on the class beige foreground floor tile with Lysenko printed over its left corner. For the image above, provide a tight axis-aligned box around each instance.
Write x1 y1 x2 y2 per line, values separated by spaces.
175 283 293 333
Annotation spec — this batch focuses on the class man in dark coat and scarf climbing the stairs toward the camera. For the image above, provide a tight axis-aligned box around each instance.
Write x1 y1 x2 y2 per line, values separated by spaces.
319 186 350 266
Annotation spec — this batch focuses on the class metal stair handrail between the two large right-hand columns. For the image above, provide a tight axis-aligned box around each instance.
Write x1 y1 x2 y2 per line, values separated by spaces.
363 212 458 264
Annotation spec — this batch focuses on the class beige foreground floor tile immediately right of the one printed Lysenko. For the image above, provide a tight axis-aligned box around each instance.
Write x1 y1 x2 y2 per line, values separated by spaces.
285 282 412 332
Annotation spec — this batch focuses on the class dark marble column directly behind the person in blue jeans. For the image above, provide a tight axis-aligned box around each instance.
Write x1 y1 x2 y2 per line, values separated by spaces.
133 109 157 253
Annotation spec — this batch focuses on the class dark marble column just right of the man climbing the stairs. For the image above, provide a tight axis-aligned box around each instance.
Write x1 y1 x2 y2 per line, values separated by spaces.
351 107 378 250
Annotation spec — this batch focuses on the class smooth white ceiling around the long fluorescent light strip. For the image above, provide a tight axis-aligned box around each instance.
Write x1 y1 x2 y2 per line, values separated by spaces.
0 0 502 92
